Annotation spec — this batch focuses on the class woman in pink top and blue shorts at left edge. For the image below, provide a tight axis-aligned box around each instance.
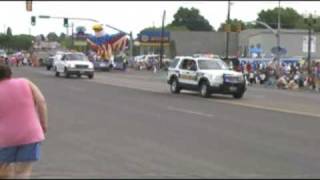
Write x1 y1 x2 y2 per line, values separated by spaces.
0 63 48 179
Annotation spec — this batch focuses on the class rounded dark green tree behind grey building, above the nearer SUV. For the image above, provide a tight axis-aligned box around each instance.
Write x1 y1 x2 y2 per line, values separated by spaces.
169 7 213 31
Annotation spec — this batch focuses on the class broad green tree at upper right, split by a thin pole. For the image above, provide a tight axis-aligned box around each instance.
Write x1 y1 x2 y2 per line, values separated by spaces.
257 8 303 29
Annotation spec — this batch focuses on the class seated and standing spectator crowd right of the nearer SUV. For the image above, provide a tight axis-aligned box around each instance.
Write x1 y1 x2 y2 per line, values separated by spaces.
240 61 320 92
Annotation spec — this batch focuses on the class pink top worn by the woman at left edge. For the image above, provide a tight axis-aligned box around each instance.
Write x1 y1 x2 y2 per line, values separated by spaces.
0 78 45 148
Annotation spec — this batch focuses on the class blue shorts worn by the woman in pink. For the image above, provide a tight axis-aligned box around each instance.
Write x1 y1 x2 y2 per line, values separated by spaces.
0 142 41 163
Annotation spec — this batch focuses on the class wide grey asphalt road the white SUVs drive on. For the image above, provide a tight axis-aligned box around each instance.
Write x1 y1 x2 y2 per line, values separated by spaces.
13 67 320 178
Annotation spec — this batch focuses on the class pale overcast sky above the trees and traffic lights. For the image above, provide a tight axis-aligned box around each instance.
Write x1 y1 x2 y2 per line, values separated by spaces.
0 1 320 37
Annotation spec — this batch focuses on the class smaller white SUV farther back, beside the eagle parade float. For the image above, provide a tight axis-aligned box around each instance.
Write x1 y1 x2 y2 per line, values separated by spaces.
54 52 94 79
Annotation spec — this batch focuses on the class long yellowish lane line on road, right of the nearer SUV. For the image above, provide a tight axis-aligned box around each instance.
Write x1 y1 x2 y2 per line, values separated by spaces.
209 100 320 118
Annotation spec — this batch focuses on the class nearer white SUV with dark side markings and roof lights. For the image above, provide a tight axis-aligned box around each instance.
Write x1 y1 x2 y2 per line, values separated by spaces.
167 56 246 99
